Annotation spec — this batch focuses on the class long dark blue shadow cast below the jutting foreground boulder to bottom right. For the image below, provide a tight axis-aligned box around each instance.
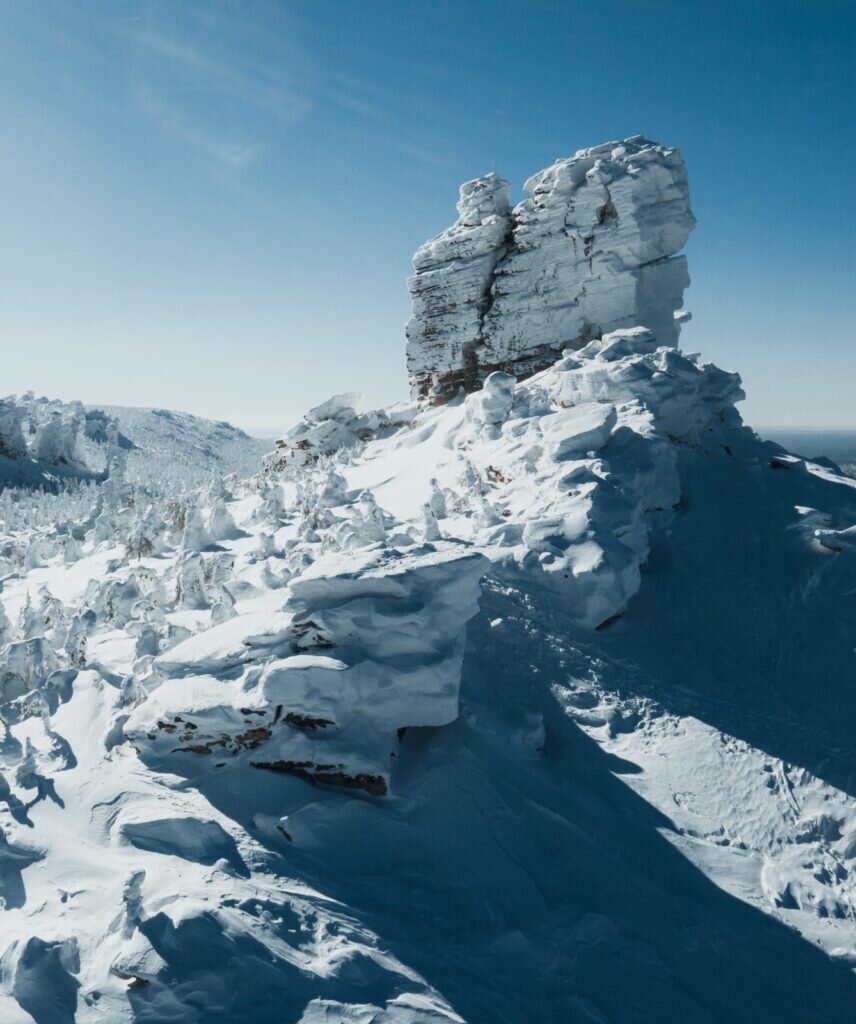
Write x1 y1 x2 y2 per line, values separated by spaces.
215 592 856 1024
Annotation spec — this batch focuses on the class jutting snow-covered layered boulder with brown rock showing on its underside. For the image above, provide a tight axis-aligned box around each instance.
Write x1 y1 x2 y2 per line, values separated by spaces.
125 544 487 795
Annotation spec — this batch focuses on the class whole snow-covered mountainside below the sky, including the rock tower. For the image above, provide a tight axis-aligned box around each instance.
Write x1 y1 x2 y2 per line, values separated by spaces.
0 137 856 1024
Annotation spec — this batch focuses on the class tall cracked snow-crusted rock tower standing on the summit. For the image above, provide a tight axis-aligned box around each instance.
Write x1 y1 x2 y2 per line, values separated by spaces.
406 136 695 400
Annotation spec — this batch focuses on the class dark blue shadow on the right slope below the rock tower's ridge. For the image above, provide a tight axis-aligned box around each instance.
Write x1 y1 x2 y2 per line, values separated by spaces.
597 445 856 797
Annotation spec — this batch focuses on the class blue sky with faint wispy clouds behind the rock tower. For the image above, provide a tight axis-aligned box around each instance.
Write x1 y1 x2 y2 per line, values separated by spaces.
0 0 856 433
